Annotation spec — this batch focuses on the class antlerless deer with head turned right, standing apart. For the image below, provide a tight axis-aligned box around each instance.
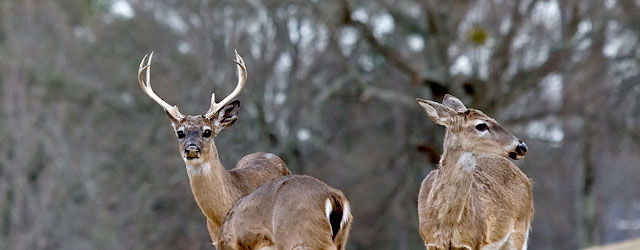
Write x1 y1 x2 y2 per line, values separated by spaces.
417 94 534 250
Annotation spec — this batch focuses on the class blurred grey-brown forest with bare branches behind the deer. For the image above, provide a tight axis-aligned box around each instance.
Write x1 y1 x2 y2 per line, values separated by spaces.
0 0 640 250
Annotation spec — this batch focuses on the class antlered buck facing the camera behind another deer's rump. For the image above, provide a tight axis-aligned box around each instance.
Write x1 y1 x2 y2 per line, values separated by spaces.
138 51 291 246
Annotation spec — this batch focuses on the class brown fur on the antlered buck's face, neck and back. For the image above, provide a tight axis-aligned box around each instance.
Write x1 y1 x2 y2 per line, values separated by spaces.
173 112 291 243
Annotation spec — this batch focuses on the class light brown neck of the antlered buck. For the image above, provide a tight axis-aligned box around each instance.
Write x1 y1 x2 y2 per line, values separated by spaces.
186 143 235 225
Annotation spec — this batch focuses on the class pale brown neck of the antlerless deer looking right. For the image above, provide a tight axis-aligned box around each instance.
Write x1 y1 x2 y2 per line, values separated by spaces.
434 132 476 223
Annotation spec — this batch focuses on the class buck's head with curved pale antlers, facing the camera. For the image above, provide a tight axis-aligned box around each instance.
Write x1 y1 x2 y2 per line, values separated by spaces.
138 51 247 164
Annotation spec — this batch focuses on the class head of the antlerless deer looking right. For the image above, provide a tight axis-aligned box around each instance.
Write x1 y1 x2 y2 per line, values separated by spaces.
417 94 527 160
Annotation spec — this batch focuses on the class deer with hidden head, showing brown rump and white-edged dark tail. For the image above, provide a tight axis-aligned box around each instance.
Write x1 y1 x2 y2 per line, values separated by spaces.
218 175 353 250
